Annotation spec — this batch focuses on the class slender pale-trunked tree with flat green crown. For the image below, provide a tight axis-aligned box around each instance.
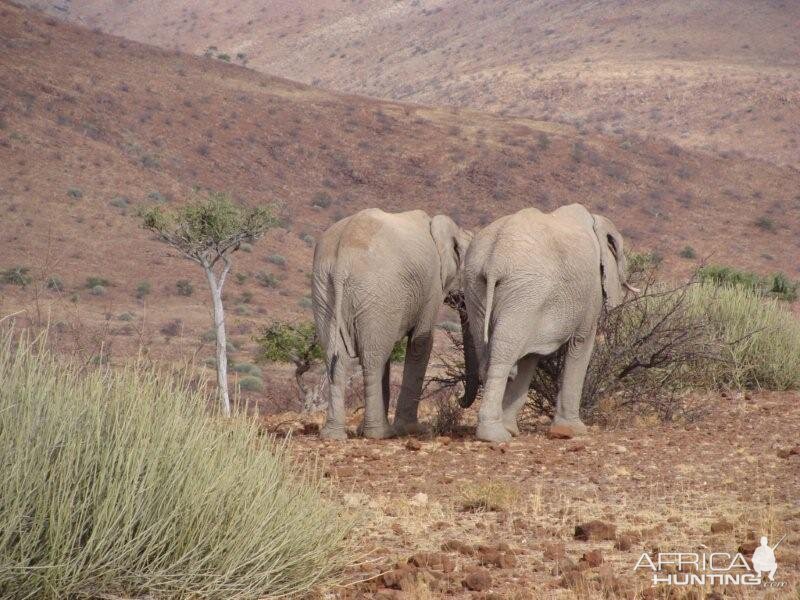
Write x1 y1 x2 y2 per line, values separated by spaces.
142 193 278 416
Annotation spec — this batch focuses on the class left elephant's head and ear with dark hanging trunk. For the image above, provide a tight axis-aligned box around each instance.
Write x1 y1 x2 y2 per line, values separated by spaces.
431 215 480 407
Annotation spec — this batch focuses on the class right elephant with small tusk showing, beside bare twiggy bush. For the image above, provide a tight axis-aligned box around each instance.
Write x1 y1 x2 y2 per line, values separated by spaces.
463 204 638 442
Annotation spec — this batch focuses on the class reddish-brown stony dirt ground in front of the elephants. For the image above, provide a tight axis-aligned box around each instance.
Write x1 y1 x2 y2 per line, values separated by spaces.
268 393 800 599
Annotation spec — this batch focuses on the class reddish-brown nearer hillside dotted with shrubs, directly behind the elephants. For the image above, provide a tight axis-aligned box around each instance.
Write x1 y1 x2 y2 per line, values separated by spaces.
0 1 800 368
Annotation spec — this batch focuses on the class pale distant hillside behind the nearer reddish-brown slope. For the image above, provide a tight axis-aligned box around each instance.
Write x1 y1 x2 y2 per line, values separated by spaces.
28 0 800 167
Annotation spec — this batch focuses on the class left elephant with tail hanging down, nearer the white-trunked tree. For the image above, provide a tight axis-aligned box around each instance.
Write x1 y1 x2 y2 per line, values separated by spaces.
312 208 477 439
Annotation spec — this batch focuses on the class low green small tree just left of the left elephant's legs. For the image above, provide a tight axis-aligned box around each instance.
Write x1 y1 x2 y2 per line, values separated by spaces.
255 322 324 409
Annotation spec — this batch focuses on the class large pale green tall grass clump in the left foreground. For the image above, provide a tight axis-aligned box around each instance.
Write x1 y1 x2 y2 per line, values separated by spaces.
0 333 350 599
